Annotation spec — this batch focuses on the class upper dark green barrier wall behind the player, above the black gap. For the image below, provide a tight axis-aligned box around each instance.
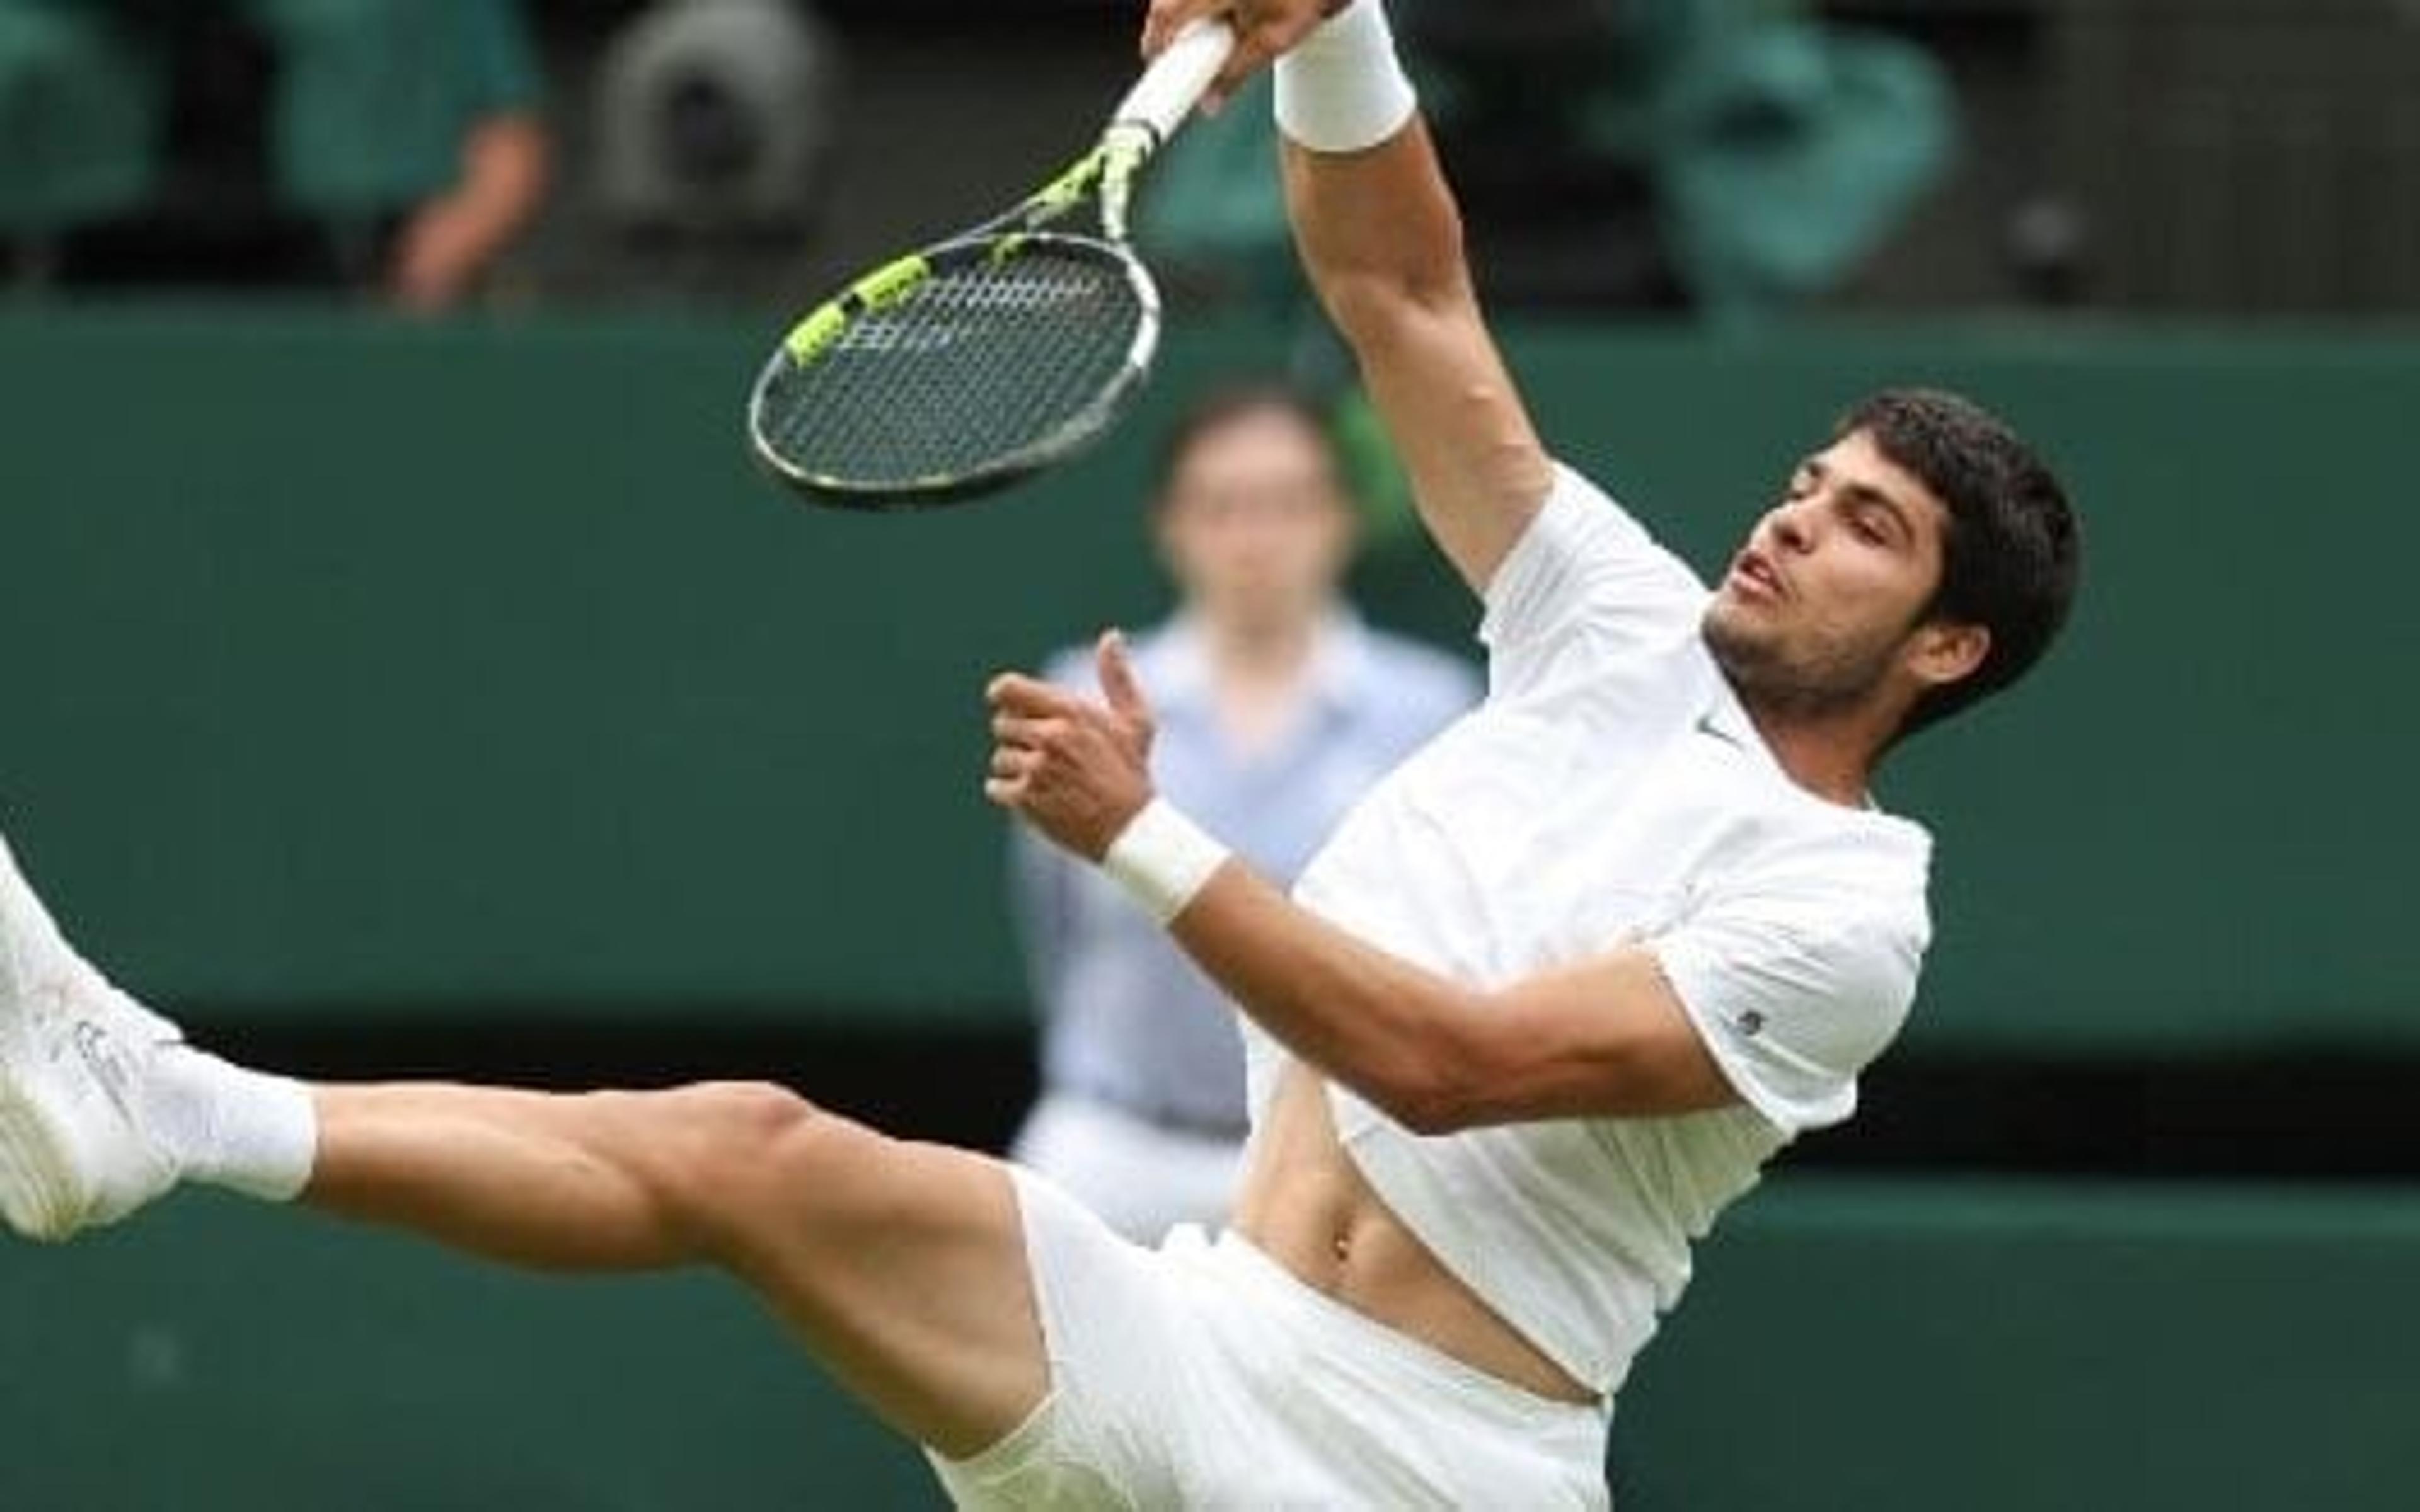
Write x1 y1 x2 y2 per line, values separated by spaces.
0 312 2420 1050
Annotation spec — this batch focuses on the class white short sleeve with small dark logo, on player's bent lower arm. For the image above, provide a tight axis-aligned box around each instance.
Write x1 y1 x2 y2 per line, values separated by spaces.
1648 871 1928 1135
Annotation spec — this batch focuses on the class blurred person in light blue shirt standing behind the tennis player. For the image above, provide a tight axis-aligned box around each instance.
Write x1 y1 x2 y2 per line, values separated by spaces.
1011 382 1478 1244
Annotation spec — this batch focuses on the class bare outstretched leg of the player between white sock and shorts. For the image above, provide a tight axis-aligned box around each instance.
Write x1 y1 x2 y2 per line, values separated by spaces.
302 1084 1048 1457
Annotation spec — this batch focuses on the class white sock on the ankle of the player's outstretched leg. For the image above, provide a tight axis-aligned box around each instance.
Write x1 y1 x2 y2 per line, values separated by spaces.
143 1045 320 1202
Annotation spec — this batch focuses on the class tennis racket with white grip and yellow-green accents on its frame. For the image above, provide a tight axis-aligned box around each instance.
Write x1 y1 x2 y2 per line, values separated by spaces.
748 20 1234 510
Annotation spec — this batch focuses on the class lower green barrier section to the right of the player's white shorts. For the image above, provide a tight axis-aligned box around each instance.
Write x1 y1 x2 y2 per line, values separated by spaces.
1614 1178 2420 1512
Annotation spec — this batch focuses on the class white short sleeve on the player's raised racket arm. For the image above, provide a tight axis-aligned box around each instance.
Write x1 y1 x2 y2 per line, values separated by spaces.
1478 462 1706 694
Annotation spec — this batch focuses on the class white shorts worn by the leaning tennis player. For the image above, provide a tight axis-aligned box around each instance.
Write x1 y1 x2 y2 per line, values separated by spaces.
930 1171 1610 1512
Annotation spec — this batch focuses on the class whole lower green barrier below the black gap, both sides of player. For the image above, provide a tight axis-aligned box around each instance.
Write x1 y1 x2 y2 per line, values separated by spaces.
0 1176 2420 1512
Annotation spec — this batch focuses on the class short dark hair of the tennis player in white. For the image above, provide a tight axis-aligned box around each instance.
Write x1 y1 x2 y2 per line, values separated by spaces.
1832 389 2083 738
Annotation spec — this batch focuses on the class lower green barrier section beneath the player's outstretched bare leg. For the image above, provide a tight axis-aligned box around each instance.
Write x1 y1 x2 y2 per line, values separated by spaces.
0 1198 944 1512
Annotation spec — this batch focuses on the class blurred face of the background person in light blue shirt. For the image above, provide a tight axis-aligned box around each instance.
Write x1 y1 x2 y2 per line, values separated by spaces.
1157 409 1353 631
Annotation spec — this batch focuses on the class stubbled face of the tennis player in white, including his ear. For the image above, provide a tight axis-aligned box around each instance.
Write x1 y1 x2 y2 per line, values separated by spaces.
1703 431 1982 716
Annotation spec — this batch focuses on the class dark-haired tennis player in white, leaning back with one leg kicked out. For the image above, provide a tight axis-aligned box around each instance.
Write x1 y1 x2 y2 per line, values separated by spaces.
0 0 2077 1507
